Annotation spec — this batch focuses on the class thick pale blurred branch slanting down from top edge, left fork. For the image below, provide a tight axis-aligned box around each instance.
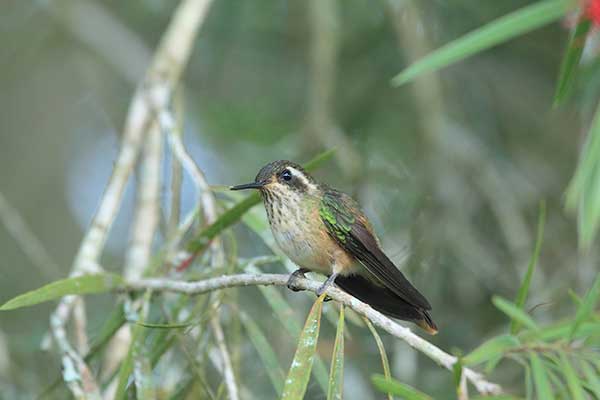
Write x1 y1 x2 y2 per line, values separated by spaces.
51 0 216 397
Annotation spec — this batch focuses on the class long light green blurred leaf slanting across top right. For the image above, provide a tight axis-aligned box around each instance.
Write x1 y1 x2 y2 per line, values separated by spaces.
392 0 571 86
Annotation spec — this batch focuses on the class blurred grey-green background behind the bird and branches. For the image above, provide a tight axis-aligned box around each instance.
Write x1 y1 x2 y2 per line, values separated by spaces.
0 0 598 399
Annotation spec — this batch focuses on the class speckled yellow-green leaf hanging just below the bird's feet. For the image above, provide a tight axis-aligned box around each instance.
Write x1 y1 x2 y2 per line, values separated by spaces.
281 294 325 400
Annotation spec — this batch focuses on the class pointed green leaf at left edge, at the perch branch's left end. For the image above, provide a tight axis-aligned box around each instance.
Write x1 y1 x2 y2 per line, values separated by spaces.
0 274 123 311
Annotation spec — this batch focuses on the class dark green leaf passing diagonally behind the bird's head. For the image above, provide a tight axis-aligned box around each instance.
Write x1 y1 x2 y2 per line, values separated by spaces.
186 149 335 253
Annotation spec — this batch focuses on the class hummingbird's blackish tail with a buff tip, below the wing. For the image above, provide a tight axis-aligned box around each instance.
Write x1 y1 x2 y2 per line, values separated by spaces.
335 275 438 335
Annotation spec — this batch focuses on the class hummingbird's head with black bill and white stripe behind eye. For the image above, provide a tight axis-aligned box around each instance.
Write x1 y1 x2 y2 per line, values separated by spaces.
230 160 319 199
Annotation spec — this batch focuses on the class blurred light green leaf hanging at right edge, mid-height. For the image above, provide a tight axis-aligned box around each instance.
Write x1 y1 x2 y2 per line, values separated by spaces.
566 101 600 248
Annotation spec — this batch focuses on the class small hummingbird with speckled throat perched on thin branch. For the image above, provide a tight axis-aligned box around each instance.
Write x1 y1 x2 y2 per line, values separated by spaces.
230 160 437 335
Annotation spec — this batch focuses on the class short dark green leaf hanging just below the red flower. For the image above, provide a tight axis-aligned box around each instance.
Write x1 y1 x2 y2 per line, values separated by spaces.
554 18 592 107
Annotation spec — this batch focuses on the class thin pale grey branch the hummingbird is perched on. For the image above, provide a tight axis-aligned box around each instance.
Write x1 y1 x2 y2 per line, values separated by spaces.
124 274 502 394
